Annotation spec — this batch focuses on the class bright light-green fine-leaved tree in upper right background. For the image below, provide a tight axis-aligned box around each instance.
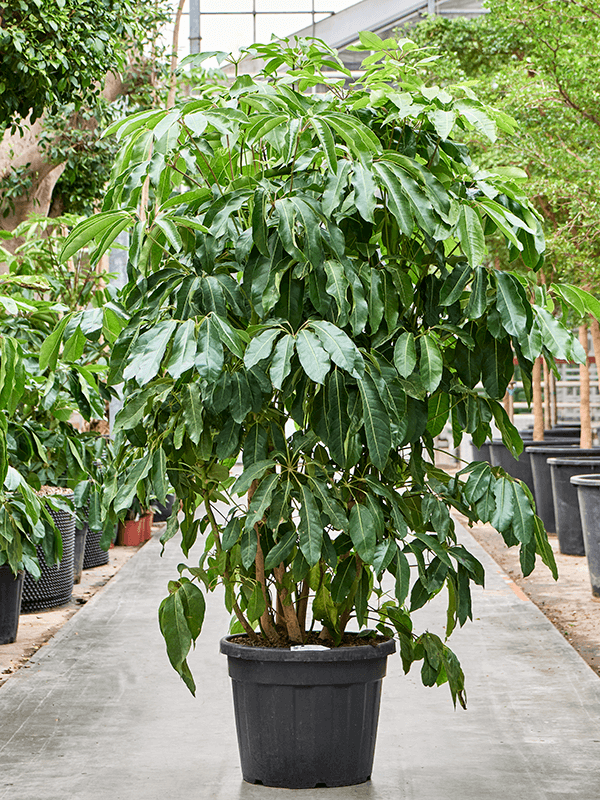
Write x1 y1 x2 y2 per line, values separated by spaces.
412 0 600 446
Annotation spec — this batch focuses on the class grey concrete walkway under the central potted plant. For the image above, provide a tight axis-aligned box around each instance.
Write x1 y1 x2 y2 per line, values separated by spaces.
0 520 600 800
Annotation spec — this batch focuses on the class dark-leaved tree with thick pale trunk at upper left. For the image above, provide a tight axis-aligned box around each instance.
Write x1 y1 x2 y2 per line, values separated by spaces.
0 0 170 230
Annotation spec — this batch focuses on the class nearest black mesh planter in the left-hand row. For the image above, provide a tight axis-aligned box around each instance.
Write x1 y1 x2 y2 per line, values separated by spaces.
21 500 75 613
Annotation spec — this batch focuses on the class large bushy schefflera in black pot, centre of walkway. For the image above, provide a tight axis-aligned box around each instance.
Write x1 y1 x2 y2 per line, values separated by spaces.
64 34 588 788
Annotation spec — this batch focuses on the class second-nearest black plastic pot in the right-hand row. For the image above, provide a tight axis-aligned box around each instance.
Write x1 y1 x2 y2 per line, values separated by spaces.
548 451 600 556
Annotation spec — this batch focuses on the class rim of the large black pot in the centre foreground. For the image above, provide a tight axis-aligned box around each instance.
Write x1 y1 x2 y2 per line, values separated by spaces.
219 633 396 663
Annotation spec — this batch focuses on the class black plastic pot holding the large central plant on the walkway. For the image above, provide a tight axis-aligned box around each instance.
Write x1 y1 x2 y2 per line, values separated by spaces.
221 637 396 789
